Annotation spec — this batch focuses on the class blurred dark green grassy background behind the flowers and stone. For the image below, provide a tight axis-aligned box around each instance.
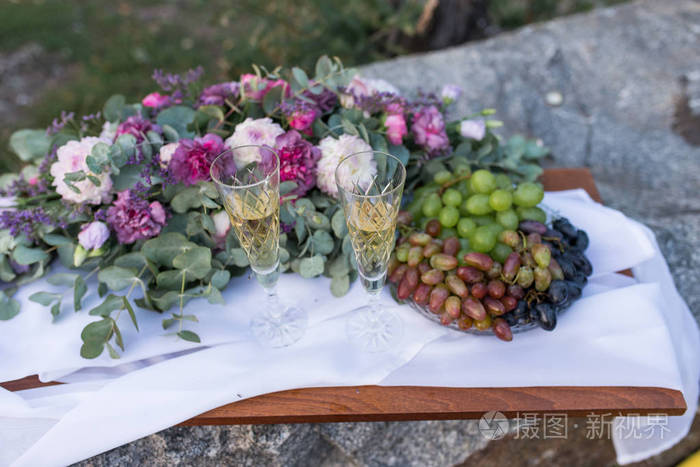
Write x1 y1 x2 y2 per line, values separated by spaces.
0 0 621 172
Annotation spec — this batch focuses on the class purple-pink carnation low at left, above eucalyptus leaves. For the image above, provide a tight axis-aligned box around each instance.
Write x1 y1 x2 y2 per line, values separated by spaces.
107 190 166 245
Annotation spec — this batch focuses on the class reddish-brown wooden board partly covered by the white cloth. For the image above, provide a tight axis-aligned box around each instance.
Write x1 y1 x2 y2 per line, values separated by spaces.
0 169 686 425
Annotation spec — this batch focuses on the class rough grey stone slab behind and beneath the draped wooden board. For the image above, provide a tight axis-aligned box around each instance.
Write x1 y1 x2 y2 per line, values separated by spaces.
84 0 700 466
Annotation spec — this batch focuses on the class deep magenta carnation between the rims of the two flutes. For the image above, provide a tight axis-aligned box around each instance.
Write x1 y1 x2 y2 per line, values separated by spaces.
275 130 321 197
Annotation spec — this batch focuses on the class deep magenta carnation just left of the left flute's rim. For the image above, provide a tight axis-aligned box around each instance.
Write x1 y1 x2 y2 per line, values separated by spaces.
168 134 226 185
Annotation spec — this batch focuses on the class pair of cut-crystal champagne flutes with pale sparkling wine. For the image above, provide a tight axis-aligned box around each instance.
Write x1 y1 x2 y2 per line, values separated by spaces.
211 145 406 352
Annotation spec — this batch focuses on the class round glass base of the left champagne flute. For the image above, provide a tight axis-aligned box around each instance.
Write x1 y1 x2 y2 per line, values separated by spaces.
250 307 309 347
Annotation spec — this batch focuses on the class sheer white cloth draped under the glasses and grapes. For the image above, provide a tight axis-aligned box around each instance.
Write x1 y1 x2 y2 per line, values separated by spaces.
0 190 700 465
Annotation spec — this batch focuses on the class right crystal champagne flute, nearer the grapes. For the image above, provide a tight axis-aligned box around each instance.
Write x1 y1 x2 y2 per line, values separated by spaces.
335 151 406 352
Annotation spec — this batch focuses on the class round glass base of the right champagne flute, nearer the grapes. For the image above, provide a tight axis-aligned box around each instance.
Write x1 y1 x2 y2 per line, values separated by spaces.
345 305 403 353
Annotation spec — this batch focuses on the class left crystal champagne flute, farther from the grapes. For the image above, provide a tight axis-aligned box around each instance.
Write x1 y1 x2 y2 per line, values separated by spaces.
211 145 308 347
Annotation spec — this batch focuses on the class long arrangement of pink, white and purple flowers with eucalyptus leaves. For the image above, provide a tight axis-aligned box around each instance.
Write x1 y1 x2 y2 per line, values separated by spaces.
0 56 547 358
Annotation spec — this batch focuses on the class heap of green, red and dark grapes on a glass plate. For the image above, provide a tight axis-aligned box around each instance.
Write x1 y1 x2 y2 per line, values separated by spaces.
388 170 592 341
